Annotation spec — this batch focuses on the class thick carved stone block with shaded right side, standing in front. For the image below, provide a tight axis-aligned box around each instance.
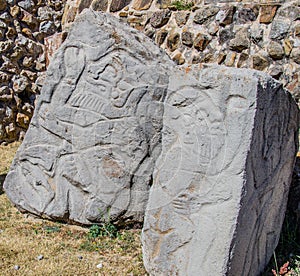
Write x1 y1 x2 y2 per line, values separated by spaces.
142 67 299 276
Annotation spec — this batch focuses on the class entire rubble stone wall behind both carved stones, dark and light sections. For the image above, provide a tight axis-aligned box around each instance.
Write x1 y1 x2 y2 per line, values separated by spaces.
0 0 300 143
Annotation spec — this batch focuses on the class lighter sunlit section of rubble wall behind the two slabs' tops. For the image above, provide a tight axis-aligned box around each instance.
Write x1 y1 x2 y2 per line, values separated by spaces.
63 0 300 101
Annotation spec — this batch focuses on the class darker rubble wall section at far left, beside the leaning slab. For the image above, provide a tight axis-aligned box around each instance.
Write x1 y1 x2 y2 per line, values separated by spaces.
0 0 64 143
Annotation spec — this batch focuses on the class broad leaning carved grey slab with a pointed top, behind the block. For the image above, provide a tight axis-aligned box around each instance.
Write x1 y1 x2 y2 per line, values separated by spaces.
4 10 173 224
